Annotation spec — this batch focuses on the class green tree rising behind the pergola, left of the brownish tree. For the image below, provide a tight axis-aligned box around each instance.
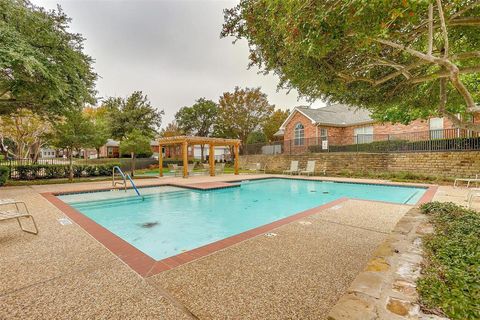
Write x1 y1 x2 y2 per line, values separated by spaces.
175 98 218 161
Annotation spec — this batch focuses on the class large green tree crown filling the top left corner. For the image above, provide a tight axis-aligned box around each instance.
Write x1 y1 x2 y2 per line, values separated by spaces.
0 0 97 116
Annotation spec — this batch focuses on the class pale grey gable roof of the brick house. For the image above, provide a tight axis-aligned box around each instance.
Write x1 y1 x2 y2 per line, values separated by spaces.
280 104 374 130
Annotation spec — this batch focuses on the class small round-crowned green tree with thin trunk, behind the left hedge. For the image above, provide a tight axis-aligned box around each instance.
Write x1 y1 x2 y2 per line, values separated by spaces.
53 111 94 181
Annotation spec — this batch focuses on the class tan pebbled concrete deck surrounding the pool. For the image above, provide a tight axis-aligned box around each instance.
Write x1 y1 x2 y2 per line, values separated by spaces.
0 174 467 319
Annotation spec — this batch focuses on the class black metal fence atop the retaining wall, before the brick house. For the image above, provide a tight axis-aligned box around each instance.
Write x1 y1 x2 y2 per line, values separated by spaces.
242 129 480 155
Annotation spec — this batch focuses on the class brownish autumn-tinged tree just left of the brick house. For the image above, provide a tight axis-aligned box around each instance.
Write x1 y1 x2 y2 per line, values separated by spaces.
215 87 275 149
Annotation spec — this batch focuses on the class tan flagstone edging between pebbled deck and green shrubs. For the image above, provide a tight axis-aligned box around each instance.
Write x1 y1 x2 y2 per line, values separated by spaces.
328 208 446 320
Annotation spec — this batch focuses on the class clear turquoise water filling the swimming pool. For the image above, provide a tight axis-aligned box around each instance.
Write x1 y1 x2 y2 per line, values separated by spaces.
59 179 426 260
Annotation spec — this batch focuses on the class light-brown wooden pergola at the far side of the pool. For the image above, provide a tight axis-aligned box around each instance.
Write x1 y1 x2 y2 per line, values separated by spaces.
158 136 240 178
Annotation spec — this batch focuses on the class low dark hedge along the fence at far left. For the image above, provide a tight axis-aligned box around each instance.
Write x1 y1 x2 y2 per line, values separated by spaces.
9 163 119 180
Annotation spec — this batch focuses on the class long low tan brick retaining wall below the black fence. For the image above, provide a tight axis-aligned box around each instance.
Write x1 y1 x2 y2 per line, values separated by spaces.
240 151 480 177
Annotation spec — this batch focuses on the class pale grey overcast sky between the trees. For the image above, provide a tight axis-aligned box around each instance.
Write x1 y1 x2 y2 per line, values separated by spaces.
33 0 323 127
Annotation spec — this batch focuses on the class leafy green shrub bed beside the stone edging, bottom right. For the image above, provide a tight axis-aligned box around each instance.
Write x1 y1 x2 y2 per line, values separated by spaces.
417 202 480 320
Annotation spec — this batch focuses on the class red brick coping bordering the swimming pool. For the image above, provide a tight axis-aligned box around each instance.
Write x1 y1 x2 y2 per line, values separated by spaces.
41 182 438 277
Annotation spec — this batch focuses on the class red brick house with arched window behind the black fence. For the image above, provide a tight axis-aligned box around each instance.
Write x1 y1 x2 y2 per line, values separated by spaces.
275 104 479 152
